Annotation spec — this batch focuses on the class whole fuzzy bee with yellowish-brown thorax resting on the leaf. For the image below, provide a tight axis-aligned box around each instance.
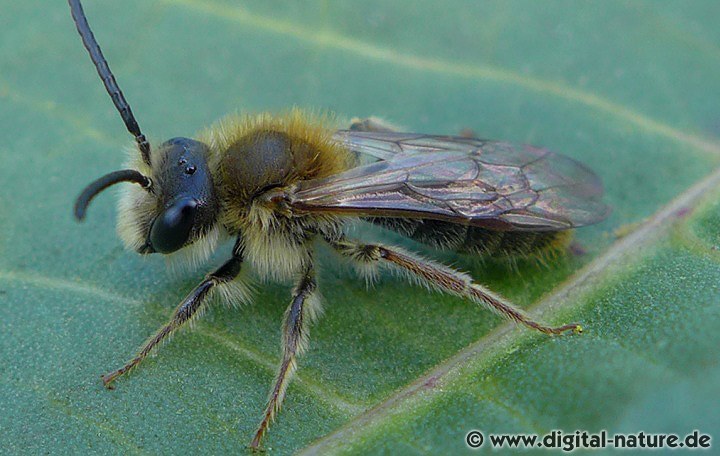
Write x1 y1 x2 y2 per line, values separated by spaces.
68 0 609 448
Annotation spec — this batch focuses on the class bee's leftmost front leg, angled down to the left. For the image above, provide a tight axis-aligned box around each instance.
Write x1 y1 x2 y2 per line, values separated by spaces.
102 245 242 388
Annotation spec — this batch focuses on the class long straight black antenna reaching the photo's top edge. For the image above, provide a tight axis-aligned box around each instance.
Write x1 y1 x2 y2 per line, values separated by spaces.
68 0 150 165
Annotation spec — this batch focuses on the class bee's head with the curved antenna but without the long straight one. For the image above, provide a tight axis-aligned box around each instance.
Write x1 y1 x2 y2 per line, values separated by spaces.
75 138 219 254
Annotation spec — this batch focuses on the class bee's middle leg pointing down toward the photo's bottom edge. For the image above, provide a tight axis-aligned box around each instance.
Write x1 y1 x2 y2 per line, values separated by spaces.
250 266 320 448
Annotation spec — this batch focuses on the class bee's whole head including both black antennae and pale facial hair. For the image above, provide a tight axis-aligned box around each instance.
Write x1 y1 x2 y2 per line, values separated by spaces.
69 0 219 254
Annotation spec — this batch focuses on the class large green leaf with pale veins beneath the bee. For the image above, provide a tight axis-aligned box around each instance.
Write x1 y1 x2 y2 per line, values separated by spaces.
0 0 720 454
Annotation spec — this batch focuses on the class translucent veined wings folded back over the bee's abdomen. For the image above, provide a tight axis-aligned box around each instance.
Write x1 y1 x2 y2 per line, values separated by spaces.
290 131 609 231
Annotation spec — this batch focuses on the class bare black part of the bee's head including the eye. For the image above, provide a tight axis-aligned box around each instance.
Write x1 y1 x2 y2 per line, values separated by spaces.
141 138 218 253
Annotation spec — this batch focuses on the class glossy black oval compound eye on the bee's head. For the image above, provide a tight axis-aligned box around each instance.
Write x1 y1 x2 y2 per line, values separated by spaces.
150 197 198 253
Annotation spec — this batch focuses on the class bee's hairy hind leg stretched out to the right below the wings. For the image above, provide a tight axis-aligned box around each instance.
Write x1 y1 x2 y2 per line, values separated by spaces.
327 239 582 334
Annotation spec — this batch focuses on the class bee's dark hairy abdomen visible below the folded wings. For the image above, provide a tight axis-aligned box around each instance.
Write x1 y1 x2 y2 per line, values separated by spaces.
369 217 571 259
